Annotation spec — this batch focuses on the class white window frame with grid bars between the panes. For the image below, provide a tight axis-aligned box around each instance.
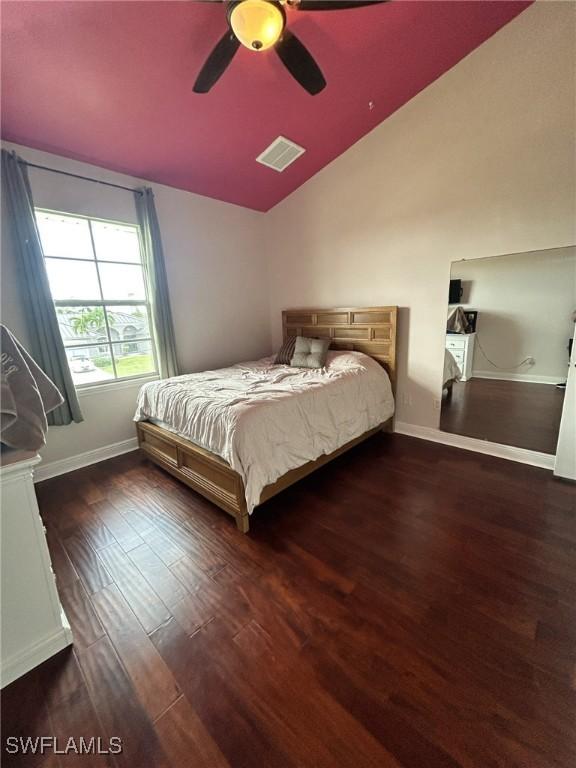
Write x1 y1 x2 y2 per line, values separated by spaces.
34 208 159 392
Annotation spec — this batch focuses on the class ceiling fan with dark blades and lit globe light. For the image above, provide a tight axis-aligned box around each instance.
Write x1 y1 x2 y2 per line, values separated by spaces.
193 0 387 94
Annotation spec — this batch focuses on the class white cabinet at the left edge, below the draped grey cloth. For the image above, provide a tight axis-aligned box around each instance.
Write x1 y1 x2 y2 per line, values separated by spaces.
0 453 72 687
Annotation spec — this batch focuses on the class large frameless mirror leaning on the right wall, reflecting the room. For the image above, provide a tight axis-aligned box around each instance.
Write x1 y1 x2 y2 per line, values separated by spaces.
440 247 576 454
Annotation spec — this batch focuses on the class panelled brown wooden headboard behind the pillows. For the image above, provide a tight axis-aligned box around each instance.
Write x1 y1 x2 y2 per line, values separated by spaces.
282 307 398 387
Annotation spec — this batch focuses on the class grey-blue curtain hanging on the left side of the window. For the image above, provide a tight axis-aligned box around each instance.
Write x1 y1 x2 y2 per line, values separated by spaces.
2 149 84 426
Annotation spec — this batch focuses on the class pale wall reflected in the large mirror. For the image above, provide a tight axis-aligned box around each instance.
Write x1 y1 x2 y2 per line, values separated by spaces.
452 248 576 383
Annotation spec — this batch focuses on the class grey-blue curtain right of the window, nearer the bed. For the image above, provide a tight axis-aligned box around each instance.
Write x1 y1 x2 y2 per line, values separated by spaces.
134 187 178 378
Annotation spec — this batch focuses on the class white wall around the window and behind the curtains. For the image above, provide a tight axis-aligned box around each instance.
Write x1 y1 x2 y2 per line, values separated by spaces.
0 143 270 463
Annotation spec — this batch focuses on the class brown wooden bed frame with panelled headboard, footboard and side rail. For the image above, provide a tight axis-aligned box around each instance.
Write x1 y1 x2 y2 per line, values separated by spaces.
136 307 397 533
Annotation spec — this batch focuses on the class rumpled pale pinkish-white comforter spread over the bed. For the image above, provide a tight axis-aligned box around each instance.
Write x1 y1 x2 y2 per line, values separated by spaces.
134 352 394 512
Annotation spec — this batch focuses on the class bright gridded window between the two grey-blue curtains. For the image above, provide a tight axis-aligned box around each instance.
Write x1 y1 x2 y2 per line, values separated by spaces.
36 210 157 386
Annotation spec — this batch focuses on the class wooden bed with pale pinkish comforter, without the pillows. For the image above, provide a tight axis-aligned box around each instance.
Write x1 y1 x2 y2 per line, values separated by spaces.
135 307 397 533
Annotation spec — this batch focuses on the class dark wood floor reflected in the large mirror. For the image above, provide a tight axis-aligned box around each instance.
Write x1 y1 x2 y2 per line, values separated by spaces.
440 379 564 454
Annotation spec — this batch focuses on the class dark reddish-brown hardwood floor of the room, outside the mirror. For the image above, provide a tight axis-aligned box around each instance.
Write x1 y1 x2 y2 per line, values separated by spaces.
2 435 576 768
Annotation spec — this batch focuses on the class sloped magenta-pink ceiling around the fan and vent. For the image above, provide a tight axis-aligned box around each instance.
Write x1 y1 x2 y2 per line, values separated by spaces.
2 0 530 210
